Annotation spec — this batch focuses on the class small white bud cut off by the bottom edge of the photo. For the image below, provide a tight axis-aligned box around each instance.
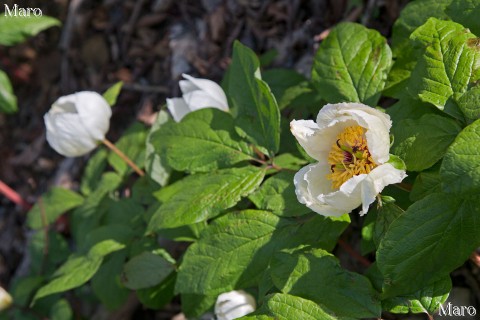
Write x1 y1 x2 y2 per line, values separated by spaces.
215 290 256 320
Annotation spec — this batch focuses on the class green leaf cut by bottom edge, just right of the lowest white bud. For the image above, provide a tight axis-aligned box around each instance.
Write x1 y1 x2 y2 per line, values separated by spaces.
255 293 345 320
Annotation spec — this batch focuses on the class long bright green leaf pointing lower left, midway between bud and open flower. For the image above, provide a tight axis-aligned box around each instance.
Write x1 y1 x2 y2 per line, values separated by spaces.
148 166 265 231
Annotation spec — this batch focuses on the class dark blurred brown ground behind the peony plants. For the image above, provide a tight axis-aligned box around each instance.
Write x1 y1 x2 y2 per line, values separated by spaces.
0 0 480 319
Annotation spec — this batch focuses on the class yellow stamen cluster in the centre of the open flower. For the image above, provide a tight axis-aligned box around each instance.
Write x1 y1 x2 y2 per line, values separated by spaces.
327 126 377 189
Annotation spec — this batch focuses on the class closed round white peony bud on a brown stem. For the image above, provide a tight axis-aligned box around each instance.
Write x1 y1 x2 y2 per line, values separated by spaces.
44 91 112 157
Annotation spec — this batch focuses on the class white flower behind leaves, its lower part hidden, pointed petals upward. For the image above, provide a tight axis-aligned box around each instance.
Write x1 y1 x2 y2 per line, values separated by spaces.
167 74 229 122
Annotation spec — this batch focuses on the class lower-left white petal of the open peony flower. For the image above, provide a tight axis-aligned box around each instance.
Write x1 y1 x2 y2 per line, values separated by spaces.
294 163 348 217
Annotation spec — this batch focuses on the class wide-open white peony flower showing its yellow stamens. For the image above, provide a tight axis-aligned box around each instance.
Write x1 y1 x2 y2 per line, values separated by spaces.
290 103 407 216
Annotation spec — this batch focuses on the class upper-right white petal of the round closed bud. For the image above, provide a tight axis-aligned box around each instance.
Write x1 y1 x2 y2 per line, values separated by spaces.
72 91 112 141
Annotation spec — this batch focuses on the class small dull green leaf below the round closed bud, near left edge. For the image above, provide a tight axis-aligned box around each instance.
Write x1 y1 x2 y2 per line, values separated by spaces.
27 187 84 229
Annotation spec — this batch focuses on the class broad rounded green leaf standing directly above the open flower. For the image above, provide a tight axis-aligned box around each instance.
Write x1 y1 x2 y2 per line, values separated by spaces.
312 23 392 106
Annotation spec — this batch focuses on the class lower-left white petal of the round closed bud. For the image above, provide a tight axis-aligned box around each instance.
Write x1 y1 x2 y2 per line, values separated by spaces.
44 113 97 157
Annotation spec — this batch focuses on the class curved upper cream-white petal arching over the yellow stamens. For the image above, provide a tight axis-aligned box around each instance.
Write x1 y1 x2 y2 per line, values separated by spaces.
317 102 392 164
